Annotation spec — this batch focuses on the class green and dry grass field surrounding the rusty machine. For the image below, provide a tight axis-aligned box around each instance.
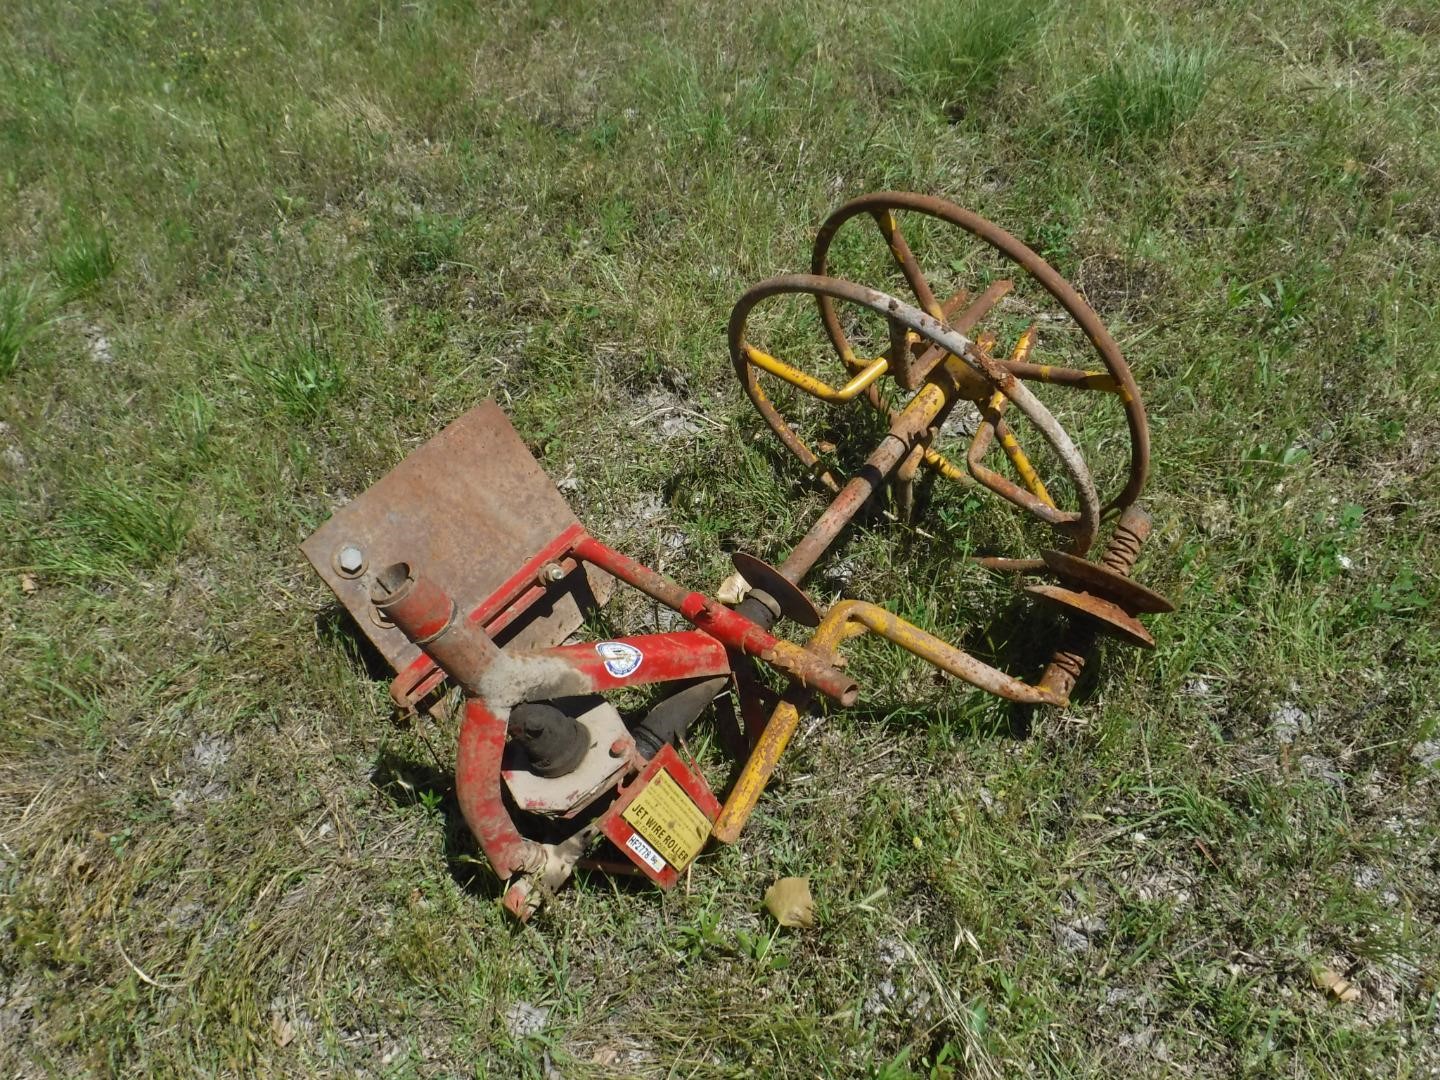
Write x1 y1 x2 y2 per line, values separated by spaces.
0 0 1440 1079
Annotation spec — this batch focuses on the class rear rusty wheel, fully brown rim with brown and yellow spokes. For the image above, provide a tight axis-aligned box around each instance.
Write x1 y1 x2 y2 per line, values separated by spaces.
817 192 1151 532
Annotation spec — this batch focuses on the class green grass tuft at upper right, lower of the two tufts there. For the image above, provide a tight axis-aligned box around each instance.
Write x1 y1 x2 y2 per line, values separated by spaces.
1073 39 1215 148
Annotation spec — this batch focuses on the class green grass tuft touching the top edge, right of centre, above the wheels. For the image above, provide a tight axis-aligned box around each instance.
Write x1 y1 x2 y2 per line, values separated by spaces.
890 0 1054 117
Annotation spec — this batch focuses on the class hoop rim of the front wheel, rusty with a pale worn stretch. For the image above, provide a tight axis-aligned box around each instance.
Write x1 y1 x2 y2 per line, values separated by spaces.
729 274 1100 553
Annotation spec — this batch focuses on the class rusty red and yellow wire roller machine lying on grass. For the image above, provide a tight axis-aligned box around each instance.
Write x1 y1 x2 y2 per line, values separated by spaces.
304 192 1169 917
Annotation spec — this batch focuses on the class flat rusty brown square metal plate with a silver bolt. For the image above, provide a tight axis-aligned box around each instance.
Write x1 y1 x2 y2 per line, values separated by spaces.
301 400 613 671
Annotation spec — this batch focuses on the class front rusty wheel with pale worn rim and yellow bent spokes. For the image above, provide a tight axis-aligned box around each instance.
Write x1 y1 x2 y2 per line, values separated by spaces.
729 274 1100 554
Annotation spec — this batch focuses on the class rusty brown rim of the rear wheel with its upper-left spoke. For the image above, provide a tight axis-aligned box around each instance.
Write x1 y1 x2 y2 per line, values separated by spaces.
811 192 1151 514
